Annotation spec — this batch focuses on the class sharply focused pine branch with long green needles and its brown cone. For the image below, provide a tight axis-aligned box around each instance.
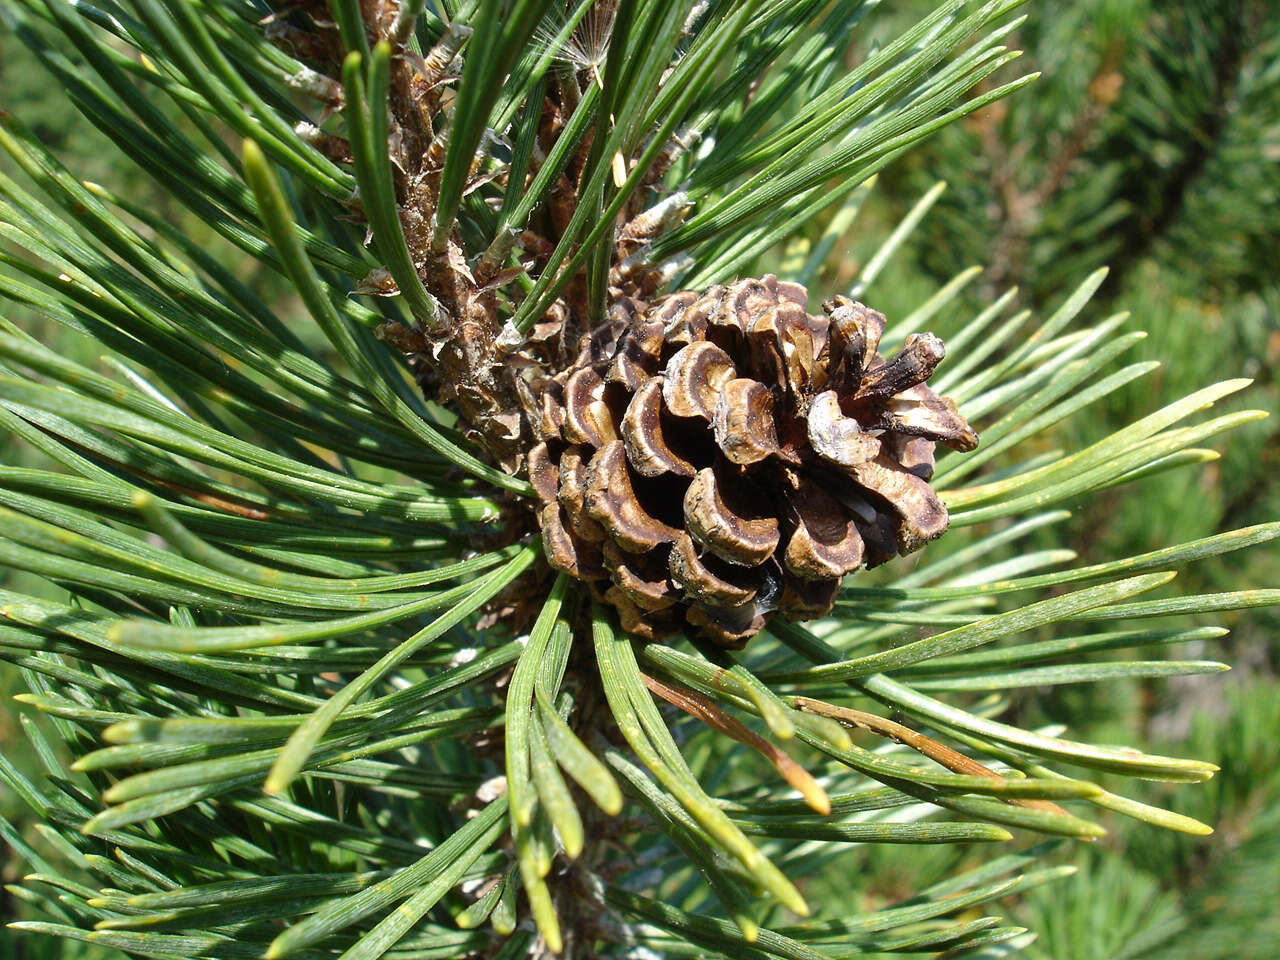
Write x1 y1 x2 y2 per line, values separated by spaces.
0 0 1280 960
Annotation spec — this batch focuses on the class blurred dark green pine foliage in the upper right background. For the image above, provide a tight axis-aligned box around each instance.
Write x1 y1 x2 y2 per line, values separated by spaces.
881 0 1280 593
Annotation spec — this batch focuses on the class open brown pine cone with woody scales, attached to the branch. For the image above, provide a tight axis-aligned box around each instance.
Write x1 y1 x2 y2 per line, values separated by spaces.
529 276 978 646
